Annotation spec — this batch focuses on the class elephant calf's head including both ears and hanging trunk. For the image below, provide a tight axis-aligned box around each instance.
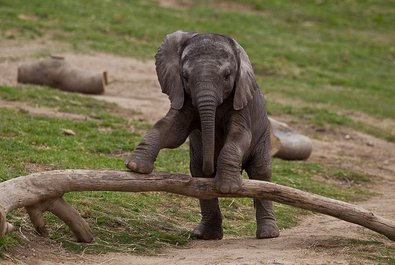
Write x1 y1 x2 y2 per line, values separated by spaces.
155 31 257 176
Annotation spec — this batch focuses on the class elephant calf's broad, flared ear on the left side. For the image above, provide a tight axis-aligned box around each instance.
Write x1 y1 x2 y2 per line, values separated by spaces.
155 31 196 110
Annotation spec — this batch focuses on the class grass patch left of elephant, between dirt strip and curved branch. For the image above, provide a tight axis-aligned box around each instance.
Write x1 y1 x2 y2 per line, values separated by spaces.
0 104 140 181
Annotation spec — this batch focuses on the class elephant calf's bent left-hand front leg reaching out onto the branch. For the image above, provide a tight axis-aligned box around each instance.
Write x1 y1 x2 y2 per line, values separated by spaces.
125 107 194 174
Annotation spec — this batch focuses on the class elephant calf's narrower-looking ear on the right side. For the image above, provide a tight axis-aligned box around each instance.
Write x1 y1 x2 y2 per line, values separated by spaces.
233 41 258 110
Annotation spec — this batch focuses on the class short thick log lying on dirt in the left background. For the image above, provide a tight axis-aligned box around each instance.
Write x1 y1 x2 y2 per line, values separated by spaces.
17 56 108 94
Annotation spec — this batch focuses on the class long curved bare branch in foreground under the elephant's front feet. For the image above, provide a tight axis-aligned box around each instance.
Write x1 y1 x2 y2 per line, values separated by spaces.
0 170 395 242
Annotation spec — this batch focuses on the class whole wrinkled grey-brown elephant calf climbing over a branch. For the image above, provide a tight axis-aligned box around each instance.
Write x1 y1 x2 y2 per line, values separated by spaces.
125 31 279 239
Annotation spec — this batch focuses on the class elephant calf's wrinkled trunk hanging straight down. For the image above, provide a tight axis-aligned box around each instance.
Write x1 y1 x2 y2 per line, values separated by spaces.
197 95 217 176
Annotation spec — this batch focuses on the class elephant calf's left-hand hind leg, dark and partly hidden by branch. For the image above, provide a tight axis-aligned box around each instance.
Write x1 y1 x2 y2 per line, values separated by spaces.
189 130 223 240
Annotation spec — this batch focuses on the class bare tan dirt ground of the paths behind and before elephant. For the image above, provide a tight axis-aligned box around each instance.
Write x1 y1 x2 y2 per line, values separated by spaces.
0 41 395 265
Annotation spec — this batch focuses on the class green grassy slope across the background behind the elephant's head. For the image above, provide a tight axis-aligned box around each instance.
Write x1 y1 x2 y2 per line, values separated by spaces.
0 0 395 123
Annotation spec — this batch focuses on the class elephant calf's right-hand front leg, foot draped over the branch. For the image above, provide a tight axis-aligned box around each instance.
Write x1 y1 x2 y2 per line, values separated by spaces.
215 126 251 193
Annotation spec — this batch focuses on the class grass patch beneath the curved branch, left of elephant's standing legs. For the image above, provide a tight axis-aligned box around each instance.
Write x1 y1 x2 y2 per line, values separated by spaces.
43 192 190 254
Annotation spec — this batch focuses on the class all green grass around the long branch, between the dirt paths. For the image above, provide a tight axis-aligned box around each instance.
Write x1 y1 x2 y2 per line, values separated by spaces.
0 86 371 253
